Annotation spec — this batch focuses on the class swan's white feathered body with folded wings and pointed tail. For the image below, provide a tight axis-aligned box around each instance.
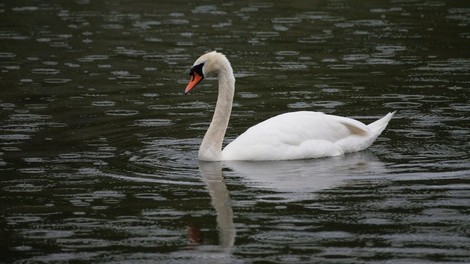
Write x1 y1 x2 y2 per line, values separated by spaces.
222 111 393 160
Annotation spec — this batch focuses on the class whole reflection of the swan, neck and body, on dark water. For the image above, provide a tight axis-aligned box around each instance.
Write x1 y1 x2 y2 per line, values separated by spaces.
195 151 385 258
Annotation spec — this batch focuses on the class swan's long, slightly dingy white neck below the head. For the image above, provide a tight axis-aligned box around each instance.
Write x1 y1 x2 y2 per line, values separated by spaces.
199 67 235 161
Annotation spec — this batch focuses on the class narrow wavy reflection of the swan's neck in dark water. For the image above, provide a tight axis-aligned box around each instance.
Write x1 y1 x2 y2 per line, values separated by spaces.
199 161 235 254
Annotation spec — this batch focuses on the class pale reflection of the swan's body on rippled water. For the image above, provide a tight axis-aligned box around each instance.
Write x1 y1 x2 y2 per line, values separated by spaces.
224 151 385 200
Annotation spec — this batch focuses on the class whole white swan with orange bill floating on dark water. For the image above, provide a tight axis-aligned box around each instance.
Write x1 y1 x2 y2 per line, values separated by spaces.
185 51 395 161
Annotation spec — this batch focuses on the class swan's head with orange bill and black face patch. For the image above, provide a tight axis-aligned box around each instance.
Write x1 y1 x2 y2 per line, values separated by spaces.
184 51 232 93
